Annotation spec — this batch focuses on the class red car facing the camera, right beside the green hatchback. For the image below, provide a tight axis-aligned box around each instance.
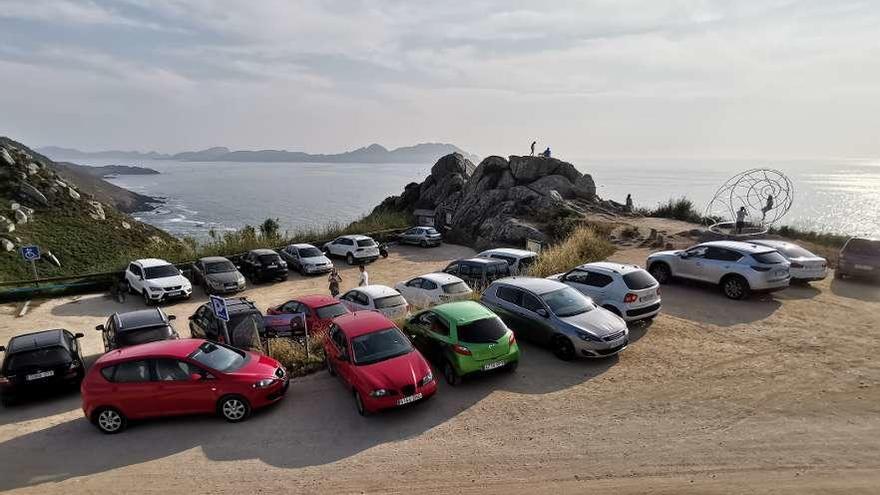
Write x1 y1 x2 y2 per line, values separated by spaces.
324 311 437 416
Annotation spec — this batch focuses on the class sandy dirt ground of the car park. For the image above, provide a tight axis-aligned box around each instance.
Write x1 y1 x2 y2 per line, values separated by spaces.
0 242 880 494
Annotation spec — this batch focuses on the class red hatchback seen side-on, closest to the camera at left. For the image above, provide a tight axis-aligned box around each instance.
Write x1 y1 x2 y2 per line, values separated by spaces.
80 339 290 433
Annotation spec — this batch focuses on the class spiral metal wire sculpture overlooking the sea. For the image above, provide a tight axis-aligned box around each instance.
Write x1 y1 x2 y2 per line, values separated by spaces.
705 168 794 236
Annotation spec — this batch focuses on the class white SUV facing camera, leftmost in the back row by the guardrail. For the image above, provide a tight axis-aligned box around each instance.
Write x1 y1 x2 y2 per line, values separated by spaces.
125 258 192 305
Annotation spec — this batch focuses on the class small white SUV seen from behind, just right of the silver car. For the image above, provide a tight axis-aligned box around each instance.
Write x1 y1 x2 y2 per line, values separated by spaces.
547 261 661 321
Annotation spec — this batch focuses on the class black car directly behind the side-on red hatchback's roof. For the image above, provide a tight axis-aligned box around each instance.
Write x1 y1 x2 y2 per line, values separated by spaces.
95 308 180 352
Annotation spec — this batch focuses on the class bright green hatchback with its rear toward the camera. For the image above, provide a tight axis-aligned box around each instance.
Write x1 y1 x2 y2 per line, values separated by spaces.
404 301 519 385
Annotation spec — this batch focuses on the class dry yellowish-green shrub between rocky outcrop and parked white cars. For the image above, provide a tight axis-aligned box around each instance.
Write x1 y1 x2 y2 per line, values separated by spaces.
529 226 614 277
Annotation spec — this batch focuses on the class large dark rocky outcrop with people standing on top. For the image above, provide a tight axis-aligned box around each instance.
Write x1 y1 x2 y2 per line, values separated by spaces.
376 153 597 248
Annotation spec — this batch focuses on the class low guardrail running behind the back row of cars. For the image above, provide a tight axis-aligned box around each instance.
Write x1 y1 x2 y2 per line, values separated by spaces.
0 228 406 303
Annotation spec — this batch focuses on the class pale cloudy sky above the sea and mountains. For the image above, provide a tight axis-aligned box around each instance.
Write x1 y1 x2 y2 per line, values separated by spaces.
0 0 880 158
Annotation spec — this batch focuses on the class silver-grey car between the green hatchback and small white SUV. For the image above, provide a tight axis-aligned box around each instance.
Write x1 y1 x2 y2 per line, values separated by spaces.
481 277 629 361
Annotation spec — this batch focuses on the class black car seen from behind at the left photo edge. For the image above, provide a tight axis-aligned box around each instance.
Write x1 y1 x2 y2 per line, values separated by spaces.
0 329 85 406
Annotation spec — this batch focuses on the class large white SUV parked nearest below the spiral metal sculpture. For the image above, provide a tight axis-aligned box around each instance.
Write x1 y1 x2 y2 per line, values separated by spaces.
647 241 791 299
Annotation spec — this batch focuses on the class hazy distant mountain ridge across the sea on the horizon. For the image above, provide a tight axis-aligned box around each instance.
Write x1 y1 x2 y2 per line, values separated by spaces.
39 143 479 163
